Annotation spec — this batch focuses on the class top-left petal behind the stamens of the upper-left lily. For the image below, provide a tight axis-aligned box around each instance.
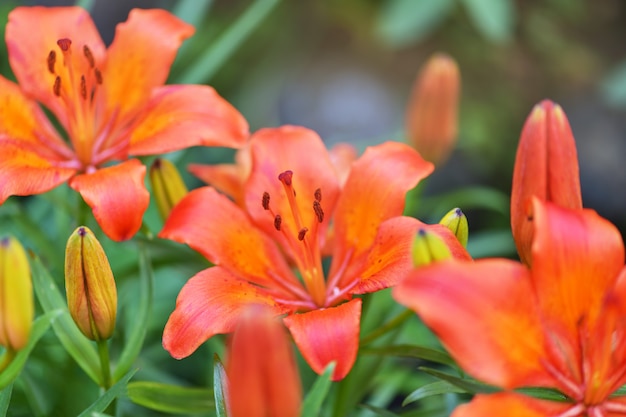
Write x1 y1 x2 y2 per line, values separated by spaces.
6 7 105 126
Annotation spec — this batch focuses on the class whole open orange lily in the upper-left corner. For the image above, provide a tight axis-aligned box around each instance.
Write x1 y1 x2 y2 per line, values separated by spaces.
0 7 248 240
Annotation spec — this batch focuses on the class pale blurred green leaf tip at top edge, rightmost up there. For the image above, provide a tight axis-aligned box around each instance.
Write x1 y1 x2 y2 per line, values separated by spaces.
462 0 515 43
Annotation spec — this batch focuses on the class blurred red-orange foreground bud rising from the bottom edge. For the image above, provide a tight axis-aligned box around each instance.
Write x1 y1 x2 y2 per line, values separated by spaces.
226 306 302 417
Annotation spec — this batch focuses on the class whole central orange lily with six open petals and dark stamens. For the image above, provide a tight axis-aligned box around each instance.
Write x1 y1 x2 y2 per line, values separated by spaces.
159 126 467 380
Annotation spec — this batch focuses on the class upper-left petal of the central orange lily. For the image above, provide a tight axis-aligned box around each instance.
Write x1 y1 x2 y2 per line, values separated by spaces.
159 187 300 288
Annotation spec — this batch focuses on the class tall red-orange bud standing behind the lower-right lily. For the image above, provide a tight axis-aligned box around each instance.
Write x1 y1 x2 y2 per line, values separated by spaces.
511 100 582 265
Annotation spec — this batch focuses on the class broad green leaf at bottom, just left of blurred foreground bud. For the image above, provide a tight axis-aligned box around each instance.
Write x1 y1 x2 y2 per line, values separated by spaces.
127 381 215 414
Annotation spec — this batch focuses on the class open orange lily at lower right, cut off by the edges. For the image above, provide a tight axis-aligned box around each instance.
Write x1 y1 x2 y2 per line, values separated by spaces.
393 198 626 417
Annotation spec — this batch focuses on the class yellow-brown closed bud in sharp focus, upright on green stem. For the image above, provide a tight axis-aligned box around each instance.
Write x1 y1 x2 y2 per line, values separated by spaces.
65 226 117 341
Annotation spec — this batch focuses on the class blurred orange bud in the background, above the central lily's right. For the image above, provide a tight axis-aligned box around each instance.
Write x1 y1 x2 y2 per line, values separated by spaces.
406 53 461 165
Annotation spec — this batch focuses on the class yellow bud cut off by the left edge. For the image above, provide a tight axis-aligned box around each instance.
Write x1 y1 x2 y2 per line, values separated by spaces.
0 237 35 351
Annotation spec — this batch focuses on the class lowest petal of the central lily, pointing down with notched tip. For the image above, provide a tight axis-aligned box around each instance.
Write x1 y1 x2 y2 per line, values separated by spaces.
284 298 361 381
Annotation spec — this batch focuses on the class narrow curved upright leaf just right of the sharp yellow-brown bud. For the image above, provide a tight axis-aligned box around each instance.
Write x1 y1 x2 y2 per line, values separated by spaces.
113 242 154 381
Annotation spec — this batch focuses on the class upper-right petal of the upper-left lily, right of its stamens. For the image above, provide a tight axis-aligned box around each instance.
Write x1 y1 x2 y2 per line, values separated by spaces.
102 9 194 120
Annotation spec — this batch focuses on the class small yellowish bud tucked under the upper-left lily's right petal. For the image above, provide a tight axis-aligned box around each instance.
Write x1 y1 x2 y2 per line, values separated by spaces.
150 158 188 219
